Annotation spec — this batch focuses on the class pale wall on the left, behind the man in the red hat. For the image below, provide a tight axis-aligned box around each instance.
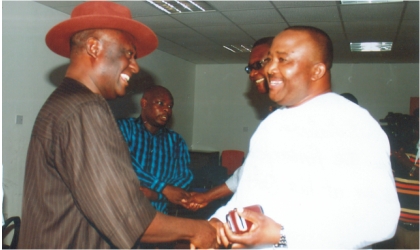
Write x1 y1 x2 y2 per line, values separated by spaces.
2 1 195 218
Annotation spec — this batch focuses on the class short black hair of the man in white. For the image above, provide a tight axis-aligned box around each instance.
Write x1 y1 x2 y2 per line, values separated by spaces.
284 26 333 70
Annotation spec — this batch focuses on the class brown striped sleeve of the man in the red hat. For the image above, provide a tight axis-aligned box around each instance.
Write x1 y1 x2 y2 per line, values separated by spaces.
64 102 156 248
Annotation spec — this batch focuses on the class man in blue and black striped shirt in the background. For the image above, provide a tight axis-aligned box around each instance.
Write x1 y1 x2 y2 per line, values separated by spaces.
118 86 193 214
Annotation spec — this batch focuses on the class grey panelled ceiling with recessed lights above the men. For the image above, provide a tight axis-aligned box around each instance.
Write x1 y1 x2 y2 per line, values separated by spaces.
39 1 419 64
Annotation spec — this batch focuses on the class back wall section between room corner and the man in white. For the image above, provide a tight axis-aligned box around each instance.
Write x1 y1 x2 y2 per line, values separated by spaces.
192 64 271 152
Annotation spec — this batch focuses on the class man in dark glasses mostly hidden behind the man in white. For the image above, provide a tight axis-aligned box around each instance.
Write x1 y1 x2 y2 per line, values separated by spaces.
188 37 274 210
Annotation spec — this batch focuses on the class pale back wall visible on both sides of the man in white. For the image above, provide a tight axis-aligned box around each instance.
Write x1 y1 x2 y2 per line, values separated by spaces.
192 63 419 152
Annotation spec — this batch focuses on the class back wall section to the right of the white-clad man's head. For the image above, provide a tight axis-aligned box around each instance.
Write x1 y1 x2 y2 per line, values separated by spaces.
332 63 419 121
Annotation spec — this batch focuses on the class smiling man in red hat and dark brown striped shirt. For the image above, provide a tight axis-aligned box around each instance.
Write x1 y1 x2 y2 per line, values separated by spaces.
19 1 217 249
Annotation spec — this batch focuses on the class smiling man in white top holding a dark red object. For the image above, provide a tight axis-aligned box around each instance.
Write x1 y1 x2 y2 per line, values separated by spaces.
208 26 400 249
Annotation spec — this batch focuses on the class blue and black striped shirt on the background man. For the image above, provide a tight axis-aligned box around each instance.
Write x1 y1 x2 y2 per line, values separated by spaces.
117 117 193 214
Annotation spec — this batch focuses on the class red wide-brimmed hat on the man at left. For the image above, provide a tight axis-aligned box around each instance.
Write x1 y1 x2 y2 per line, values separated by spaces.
45 1 158 58
